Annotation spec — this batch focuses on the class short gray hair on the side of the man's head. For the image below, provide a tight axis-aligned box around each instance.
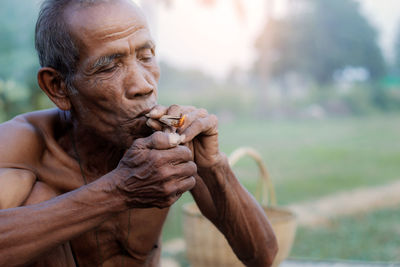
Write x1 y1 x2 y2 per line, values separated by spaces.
35 0 105 88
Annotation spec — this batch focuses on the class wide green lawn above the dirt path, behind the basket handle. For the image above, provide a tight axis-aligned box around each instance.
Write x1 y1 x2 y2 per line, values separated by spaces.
220 116 400 204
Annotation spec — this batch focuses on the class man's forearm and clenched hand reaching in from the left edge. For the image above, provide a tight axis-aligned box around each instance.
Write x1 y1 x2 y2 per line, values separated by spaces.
0 129 196 266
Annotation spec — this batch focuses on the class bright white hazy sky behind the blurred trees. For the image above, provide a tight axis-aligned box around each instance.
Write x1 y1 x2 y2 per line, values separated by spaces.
133 0 400 78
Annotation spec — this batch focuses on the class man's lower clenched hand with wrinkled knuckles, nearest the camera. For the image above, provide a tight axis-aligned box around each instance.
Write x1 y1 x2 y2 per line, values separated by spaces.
113 132 197 208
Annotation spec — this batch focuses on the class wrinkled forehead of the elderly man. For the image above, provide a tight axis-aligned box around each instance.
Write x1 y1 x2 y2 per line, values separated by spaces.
64 0 150 51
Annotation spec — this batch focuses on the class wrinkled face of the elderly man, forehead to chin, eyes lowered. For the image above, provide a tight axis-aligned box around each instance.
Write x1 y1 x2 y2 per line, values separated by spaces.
65 0 160 147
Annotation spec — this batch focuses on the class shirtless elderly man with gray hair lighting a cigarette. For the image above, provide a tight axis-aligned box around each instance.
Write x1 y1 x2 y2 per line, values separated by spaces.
0 0 277 267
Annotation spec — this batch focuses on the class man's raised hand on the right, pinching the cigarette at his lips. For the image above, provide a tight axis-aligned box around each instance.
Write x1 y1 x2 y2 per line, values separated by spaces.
147 105 221 168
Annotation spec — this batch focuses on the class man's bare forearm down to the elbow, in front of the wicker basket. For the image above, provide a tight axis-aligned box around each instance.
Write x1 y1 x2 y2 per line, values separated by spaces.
191 157 277 267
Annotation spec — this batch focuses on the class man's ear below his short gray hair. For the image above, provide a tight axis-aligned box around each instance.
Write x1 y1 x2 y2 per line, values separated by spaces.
37 67 71 110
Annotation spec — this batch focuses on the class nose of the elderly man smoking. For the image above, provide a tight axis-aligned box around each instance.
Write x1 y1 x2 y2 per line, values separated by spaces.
125 63 155 99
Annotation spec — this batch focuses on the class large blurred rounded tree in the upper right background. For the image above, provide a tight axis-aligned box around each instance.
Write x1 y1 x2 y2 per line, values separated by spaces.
254 0 385 84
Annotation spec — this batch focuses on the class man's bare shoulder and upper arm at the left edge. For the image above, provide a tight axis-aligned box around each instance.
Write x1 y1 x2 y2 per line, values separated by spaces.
0 110 57 209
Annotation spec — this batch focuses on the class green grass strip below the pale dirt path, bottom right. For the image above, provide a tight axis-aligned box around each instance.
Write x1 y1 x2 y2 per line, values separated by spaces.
291 209 400 262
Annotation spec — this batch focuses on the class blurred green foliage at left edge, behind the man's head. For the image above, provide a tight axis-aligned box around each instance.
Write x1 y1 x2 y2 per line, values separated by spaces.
0 0 50 120
